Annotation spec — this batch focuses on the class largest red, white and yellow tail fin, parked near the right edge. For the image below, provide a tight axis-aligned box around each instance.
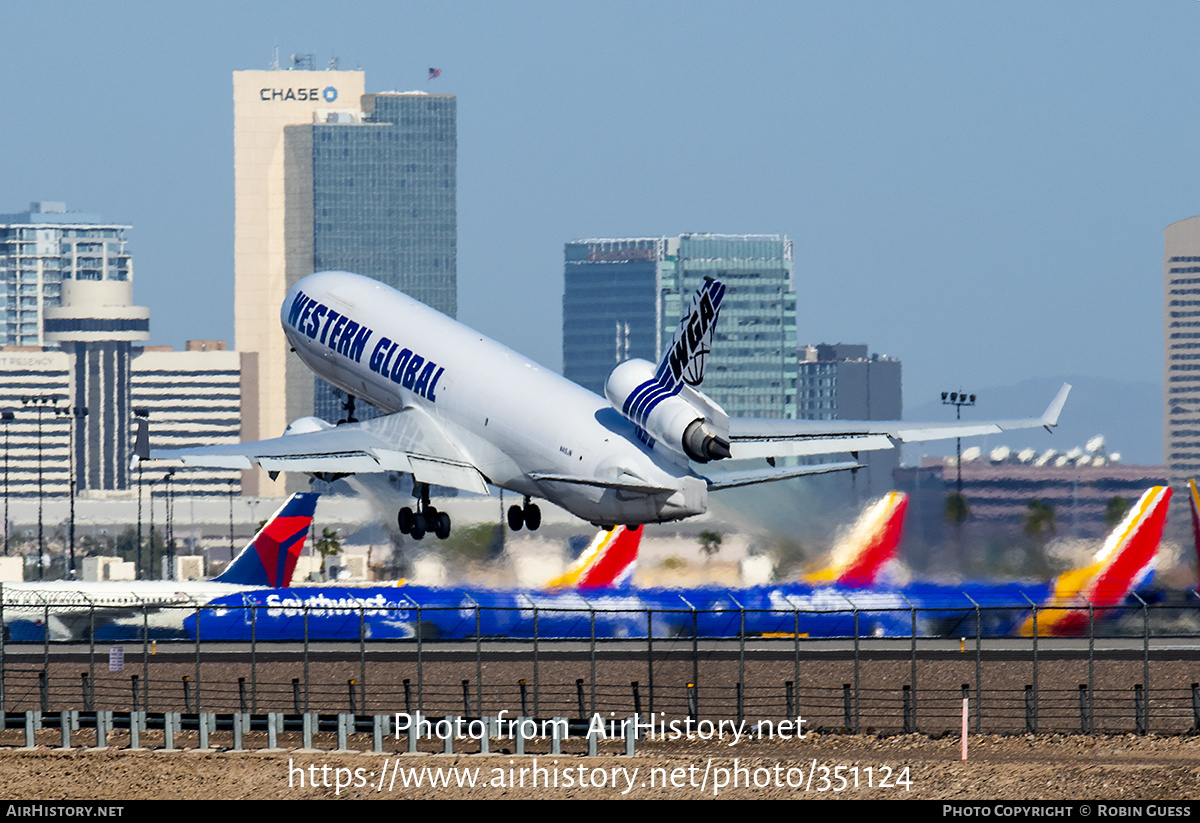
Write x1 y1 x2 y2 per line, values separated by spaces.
1021 486 1171 637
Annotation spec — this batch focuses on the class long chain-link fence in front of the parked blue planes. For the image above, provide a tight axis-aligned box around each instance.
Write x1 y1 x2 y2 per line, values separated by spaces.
0 595 1200 733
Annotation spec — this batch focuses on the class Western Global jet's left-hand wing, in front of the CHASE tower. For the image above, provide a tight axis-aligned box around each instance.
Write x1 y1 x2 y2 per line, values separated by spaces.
139 408 488 494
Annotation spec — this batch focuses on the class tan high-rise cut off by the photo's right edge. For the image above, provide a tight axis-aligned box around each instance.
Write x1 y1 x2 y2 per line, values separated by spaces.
1163 217 1200 488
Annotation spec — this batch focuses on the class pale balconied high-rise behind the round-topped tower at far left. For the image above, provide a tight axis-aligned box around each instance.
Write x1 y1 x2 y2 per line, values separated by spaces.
0 206 133 347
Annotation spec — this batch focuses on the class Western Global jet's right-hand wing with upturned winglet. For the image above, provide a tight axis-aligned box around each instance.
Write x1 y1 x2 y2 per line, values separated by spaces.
730 383 1070 459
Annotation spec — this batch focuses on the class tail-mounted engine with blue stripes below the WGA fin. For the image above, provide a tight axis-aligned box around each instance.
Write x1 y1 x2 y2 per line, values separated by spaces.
604 360 730 463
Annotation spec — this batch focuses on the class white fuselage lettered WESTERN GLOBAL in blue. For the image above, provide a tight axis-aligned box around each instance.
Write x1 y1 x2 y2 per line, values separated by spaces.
281 271 707 524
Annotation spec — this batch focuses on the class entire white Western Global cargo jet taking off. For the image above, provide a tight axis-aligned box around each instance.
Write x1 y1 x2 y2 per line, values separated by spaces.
136 271 1070 539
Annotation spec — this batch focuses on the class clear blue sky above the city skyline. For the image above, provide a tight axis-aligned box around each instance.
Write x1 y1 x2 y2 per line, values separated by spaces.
0 0 1185 458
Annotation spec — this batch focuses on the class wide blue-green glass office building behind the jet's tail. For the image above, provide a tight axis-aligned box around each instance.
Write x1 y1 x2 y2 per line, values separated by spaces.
563 234 797 417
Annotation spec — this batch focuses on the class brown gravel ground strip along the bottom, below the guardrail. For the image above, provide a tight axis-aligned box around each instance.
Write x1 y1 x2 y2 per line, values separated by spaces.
0 734 1200 801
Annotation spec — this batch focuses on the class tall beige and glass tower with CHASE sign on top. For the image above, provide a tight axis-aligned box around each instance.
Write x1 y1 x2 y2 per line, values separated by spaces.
234 71 457 494
